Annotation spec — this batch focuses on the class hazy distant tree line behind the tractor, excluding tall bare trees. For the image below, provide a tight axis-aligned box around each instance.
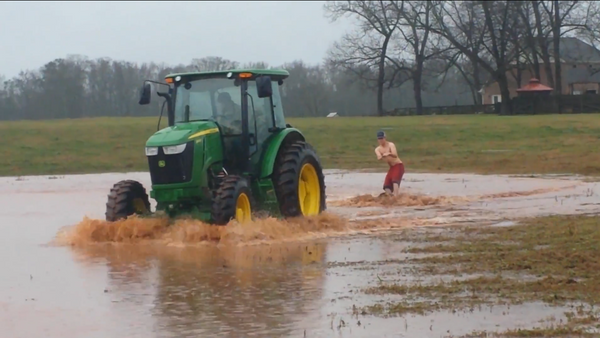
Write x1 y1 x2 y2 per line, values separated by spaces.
0 55 478 120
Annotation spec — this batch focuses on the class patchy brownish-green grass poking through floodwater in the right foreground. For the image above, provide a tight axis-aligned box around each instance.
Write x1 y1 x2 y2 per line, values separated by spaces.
364 216 600 337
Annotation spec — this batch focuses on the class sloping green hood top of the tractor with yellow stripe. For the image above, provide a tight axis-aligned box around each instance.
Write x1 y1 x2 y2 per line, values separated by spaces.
146 121 218 147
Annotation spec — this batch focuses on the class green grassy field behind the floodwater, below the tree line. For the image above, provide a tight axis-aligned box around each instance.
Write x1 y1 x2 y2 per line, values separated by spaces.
0 115 600 176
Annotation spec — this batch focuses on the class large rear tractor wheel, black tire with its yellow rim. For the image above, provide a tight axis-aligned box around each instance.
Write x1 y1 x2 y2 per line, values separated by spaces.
273 141 326 217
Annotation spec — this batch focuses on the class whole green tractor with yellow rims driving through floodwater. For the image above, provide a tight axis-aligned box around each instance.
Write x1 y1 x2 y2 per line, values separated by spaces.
105 69 326 225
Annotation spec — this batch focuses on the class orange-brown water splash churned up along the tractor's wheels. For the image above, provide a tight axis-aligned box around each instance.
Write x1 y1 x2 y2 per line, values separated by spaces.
54 213 351 246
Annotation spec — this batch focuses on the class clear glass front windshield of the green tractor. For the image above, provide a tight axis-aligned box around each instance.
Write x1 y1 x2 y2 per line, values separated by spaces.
175 78 242 135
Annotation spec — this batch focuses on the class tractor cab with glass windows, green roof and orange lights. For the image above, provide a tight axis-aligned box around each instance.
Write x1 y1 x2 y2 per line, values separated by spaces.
142 70 287 175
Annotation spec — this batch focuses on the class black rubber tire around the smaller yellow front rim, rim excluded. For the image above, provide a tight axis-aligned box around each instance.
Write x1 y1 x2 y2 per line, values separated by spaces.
211 175 254 225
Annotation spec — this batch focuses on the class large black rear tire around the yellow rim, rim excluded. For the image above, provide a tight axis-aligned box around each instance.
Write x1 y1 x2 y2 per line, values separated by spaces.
273 141 327 218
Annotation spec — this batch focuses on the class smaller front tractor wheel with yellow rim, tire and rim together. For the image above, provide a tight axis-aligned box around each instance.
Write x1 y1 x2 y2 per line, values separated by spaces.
211 175 254 225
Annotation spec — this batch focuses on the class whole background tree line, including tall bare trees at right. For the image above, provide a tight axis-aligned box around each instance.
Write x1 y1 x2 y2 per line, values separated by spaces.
0 0 600 120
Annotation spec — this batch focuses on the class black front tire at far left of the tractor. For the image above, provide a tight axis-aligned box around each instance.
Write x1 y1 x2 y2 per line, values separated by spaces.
105 180 150 222
